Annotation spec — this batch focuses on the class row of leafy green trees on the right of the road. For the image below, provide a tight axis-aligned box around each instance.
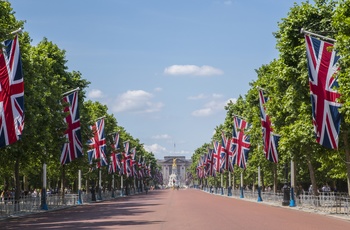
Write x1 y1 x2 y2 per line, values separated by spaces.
192 0 350 194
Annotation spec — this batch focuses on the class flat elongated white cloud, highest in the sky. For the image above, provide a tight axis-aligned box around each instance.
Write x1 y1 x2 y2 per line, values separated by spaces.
164 65 224 76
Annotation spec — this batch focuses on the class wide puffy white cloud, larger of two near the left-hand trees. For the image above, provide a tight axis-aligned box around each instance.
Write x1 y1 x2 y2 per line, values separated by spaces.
112 90 163 113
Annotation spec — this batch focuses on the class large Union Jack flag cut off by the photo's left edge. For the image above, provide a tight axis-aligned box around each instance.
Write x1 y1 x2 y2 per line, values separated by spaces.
0 36 24 147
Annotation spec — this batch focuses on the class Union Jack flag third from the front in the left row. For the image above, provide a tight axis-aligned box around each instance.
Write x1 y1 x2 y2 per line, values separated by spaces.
88 118 108 168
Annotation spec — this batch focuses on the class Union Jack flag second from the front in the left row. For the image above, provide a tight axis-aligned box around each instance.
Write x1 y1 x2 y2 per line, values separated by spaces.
61 91 83 165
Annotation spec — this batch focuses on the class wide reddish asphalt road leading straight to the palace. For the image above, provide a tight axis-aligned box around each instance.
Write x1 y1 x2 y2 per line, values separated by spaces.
0 189 350 230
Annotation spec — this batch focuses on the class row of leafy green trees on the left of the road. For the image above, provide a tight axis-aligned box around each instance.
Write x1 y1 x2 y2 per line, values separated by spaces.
0 1 156 198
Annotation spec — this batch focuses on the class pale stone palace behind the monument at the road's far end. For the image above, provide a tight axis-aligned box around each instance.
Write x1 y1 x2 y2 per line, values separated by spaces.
157 156 192 186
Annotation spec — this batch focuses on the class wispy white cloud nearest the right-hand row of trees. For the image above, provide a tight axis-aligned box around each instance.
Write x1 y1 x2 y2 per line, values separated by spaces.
191 94 237 117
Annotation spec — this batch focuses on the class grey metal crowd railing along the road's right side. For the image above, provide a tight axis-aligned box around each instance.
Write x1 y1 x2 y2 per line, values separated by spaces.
202 187 350 217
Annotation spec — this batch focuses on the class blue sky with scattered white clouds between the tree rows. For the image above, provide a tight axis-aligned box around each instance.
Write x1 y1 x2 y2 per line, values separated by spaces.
9 0 301 159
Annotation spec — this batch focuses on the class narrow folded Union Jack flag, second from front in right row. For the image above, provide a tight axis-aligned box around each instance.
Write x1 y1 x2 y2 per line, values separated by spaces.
259 89 280 163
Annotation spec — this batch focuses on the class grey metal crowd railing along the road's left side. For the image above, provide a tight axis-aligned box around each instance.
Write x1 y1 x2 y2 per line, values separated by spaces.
0 189 137 219
